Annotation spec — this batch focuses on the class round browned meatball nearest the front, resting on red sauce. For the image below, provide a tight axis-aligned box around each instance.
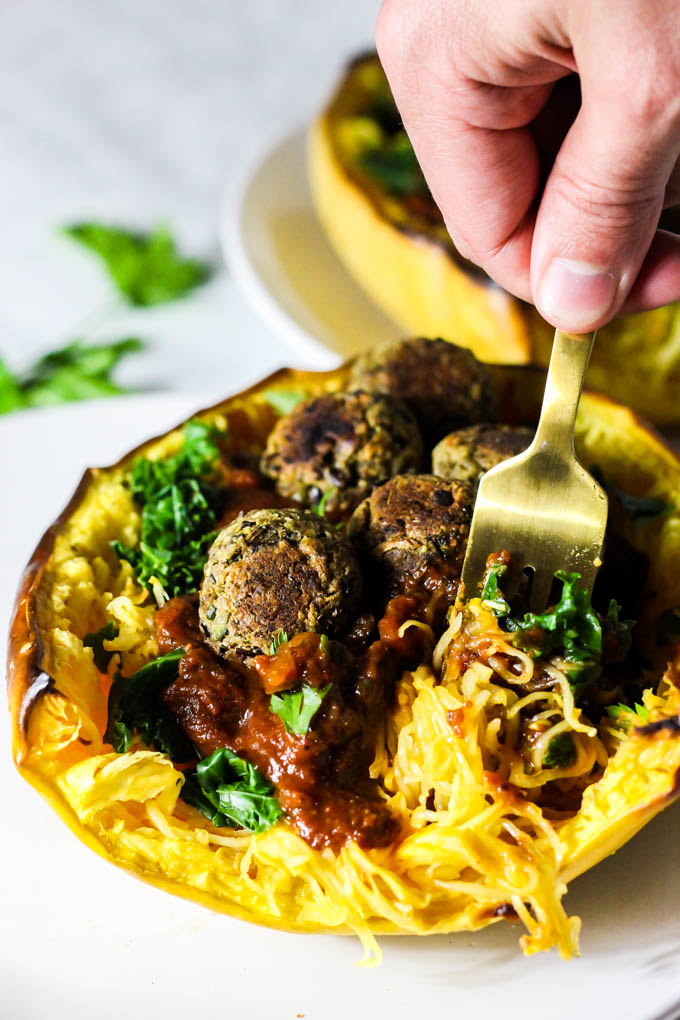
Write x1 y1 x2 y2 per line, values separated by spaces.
199 509 361 658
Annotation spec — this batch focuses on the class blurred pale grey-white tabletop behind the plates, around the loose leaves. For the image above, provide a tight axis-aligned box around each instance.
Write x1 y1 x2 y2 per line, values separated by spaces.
0 0 379 395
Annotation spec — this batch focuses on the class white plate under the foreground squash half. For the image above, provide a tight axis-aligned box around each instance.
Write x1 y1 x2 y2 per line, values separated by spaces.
0 396 680 1020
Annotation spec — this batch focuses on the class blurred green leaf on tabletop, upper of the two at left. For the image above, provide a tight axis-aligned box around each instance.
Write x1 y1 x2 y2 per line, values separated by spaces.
64 223 212 307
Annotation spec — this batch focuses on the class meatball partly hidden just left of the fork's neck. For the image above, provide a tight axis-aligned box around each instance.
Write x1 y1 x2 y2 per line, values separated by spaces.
432 425 533 485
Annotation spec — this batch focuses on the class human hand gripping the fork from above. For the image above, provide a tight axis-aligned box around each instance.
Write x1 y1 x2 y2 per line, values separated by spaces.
377 0 680 333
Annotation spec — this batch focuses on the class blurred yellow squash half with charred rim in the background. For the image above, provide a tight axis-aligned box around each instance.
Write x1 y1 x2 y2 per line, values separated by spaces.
309 53 680 425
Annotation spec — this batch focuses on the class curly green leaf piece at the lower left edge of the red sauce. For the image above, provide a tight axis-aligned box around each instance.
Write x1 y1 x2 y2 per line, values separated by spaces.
180 748 281 832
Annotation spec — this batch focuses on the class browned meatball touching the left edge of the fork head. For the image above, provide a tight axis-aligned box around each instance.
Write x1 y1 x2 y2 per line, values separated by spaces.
348 474 473 595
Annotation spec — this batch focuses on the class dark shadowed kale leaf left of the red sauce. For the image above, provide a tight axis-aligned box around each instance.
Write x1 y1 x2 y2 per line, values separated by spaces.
104 648 195 762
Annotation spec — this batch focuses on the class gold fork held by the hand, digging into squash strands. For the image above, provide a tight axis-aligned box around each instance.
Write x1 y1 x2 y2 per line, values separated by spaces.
462 329 608 613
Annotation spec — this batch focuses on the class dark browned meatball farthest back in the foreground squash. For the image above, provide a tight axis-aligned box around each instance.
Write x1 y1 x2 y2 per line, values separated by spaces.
351 337 495 444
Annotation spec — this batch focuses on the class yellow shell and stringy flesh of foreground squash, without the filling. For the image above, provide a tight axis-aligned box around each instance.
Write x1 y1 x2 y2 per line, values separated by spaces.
8 366 680 956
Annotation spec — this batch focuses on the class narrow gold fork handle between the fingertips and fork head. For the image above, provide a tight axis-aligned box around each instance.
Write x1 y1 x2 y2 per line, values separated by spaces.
532 329 595 456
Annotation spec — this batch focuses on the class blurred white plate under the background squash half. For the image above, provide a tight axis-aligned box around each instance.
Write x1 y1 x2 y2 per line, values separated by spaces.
221 130 402 368
